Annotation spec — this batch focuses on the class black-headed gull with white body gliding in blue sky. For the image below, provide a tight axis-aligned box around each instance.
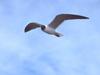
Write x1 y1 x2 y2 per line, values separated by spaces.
24 14 89 37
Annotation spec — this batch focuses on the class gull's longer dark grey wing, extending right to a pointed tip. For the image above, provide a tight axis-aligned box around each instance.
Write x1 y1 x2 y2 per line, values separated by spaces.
49 14 89 29
